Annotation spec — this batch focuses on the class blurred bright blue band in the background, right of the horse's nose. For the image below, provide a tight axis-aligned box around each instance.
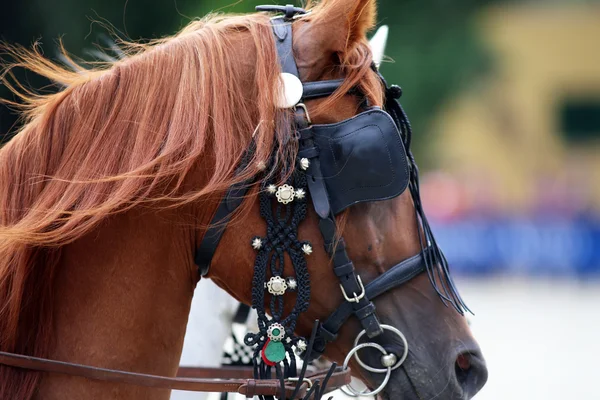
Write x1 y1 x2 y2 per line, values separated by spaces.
431 215 600 277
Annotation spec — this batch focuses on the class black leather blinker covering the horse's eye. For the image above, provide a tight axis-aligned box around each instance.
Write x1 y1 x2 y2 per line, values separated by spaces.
299 108 410 214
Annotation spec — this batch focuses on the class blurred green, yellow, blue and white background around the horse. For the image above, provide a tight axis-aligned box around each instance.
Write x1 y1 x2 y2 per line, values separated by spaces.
0 0 600 400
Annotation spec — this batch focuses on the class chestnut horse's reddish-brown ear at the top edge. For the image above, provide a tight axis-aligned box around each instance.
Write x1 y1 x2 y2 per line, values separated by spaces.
302 0 377 54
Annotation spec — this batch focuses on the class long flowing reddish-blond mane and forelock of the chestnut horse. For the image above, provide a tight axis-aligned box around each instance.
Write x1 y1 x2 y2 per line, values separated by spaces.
0 7 381 399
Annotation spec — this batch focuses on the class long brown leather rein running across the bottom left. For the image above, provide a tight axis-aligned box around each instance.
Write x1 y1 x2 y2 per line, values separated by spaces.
0 351 351 399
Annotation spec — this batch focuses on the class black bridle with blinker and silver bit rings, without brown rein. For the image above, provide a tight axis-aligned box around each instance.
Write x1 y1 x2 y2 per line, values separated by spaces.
196 5 468 395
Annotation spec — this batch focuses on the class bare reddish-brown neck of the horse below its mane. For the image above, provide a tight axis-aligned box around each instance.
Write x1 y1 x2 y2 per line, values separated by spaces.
38 206 197 400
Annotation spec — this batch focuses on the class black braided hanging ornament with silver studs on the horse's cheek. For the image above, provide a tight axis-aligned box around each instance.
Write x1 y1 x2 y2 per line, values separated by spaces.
244 171 312 400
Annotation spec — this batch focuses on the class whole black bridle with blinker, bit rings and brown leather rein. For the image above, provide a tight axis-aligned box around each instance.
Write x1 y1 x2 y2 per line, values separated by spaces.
0 5 468 399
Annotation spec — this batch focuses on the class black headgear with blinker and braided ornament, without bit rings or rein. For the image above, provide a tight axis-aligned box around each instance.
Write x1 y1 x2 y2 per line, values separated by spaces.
195 6 468 396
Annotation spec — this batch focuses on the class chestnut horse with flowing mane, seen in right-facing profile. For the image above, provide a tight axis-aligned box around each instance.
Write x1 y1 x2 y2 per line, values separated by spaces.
0 0 487 400
